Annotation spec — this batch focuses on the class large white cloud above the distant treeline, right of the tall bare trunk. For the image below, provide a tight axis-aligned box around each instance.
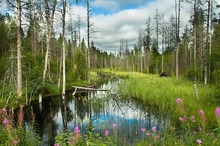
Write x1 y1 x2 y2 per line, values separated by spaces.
87 0 192 51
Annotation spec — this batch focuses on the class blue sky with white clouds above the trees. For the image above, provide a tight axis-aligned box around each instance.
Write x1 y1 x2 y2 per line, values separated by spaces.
0 0 220 52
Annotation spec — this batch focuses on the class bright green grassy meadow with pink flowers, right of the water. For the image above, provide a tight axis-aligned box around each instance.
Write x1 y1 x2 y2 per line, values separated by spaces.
95 70 220 146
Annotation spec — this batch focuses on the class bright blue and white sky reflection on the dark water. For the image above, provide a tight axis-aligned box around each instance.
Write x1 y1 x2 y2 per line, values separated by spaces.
50 82 168 145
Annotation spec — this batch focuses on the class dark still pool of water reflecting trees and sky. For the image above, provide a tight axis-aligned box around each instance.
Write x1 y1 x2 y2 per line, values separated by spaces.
22 81 169 146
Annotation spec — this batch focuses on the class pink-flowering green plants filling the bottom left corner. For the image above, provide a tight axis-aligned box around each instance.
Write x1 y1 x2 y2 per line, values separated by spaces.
0 107 41 146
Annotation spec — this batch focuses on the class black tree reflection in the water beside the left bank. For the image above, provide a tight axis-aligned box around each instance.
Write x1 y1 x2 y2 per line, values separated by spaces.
24 97 59 145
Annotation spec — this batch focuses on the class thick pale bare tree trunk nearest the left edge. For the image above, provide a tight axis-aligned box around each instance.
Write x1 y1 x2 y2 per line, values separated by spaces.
17 0 22 97
